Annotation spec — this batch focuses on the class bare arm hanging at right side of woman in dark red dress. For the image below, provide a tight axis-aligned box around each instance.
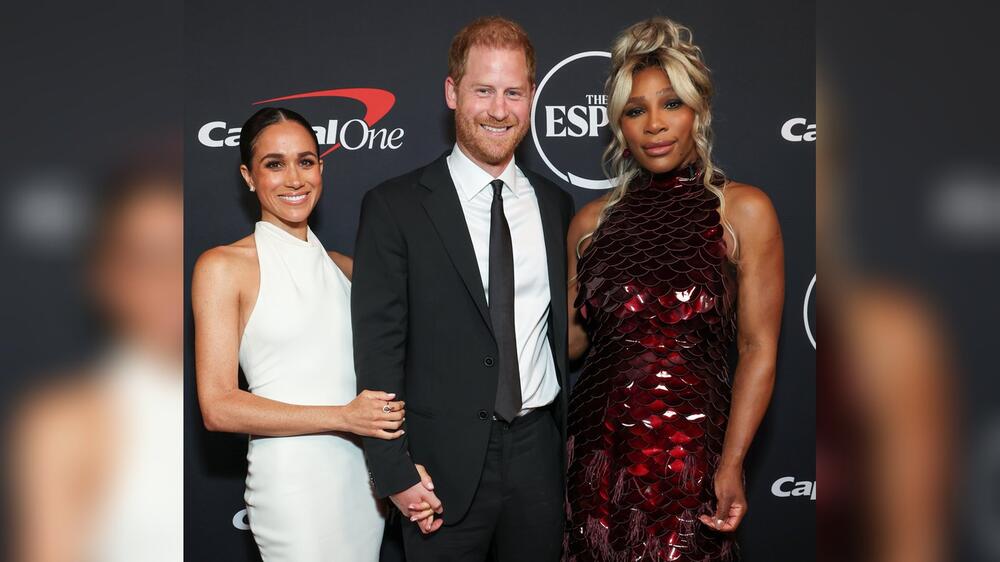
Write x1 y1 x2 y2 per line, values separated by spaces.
702 184 785 531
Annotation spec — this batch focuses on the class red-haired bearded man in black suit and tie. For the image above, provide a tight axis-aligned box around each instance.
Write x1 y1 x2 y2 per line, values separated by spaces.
351 17 573 562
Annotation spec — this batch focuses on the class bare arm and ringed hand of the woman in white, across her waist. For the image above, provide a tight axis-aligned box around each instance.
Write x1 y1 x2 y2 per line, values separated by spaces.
191 249 404 439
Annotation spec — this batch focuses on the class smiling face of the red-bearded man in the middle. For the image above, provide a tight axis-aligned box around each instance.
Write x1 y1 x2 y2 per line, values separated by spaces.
445 45 535 176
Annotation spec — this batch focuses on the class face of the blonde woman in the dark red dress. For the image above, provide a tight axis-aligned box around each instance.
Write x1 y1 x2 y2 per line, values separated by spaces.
620 67 697 174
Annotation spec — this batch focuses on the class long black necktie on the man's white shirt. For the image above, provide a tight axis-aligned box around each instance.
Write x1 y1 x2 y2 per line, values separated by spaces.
489 180 521 421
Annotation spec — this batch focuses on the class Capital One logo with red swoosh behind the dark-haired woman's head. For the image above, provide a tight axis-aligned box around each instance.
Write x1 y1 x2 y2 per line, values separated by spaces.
198 88 404 158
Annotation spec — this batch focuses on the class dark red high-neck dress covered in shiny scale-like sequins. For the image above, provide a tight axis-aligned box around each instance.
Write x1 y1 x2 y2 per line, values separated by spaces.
565 166 737 562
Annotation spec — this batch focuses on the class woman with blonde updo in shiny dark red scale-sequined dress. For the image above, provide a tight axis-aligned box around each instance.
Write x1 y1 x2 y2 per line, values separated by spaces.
566 18 784 562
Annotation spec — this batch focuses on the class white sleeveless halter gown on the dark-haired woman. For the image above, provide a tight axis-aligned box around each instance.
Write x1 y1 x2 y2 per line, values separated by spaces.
240 221 384 562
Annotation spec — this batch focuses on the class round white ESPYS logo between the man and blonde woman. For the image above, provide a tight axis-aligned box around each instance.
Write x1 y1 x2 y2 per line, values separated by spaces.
531 51 612 189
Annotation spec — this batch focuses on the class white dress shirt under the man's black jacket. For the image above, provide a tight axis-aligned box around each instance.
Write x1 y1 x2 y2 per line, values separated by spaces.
447 144 564 415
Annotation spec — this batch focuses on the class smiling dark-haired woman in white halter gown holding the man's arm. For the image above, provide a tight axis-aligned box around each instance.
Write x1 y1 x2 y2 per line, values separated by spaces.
191 108 412 562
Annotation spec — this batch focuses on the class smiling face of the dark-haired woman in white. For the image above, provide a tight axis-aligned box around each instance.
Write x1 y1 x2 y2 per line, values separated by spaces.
240 121 323 226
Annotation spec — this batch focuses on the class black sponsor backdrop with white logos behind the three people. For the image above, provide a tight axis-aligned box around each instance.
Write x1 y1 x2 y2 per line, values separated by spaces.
184 0 815 561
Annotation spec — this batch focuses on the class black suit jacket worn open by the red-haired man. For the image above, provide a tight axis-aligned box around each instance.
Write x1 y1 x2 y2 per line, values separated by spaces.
351 153 574 523
